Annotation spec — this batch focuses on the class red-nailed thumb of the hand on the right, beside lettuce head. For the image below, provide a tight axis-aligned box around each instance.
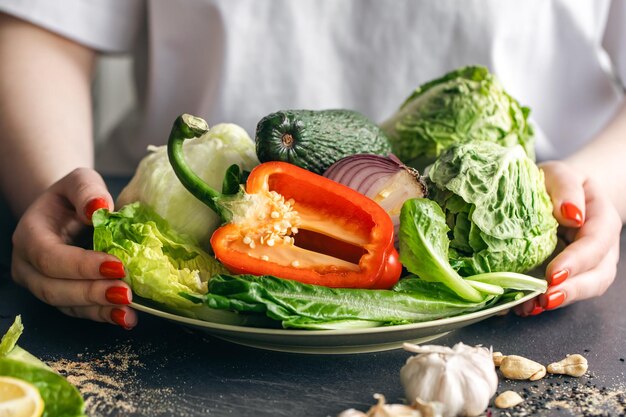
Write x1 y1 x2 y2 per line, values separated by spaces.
541 162 586 227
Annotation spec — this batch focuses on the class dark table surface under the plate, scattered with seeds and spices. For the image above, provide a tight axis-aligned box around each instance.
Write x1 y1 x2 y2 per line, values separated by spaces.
0 184 626 417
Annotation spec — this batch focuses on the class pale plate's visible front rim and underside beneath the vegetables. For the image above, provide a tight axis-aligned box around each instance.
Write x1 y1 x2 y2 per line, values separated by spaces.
131 292 540 354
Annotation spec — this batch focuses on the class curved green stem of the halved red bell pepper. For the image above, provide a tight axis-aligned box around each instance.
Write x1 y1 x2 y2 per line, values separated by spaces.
167 114 232 222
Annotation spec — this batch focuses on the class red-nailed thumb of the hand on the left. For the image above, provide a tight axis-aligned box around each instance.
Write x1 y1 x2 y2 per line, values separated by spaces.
53 168 114 224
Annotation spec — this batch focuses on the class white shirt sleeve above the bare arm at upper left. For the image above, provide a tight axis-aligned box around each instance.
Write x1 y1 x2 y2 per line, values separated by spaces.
0 0 145 52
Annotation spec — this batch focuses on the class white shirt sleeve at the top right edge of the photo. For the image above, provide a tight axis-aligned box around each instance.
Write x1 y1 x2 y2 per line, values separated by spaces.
602 0 626 88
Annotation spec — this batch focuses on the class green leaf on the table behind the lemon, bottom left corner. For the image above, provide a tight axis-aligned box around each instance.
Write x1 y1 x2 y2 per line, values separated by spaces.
0 316 85 417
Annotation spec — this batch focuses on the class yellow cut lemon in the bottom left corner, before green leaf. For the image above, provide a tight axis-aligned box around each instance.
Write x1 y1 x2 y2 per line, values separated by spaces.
0 376 44 417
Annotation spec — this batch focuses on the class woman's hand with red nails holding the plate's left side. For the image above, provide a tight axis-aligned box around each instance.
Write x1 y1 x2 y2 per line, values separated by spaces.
11 168 137 329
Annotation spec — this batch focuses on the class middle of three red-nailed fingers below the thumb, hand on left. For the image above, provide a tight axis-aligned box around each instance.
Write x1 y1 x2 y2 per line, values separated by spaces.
15 262 132 307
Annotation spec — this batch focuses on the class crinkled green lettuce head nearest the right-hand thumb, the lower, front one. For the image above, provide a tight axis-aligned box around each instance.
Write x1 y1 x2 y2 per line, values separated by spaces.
428 142 558 276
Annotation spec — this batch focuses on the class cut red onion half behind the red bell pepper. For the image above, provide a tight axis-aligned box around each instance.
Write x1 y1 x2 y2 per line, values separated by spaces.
324 154 427 246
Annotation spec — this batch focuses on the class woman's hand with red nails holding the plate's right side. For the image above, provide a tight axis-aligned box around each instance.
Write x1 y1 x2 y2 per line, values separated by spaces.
515 161 622 316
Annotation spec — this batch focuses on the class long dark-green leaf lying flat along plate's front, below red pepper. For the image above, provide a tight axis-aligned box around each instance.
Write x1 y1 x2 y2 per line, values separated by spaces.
187 274 493 329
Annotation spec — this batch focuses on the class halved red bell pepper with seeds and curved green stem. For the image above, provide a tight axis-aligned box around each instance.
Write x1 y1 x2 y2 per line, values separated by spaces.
168 115 402 288
